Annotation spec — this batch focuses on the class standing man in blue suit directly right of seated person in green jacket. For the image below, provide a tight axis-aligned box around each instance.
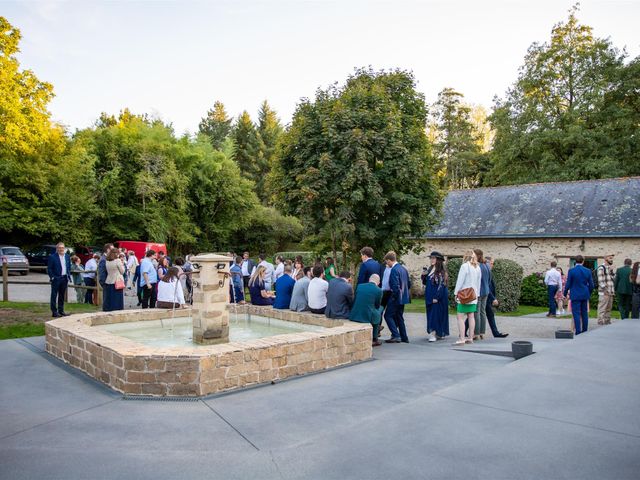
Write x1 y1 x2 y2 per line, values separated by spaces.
384 252 411 343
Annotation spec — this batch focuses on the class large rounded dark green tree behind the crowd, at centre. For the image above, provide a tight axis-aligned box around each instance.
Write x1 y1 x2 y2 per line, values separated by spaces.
270 69 440 266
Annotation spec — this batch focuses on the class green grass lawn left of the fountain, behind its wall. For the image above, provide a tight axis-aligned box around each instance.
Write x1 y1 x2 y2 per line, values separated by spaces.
0 302 98 340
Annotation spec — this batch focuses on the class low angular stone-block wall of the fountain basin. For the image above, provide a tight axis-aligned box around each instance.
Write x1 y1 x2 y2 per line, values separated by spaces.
45 305 372 396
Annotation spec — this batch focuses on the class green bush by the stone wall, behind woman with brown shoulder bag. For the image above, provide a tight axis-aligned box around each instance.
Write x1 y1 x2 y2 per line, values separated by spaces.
447 258 522 312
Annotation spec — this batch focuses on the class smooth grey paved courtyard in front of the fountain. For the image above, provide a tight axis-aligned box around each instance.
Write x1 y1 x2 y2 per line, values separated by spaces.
0 321 640 480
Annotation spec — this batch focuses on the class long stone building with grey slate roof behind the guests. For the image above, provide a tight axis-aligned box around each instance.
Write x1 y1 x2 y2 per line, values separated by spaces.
403 177 640 278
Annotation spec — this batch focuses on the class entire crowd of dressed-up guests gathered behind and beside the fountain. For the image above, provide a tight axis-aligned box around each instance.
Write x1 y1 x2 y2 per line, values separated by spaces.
48 243 640 346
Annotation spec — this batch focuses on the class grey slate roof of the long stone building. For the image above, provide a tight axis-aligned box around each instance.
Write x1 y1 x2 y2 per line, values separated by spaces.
425 177 640 238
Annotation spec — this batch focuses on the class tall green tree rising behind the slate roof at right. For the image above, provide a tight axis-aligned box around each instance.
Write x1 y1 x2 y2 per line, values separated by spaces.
488 6 637 184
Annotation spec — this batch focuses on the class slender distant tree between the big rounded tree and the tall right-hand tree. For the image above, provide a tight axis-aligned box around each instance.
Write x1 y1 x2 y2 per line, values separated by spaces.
432 88 482 189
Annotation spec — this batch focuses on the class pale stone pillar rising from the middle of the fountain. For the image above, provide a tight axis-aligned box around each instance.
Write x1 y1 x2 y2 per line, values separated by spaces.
189 253 231 345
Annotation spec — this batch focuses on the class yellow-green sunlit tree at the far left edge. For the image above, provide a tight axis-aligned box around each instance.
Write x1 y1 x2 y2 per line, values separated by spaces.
0 17 94 244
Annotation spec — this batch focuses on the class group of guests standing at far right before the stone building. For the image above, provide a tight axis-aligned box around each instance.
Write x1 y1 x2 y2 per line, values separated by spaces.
544 254 640 335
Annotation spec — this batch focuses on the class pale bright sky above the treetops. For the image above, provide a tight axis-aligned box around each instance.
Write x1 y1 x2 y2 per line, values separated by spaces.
5 0 640 134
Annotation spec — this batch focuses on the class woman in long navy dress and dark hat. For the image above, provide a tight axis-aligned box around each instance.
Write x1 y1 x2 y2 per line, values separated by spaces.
422 252 449 342
